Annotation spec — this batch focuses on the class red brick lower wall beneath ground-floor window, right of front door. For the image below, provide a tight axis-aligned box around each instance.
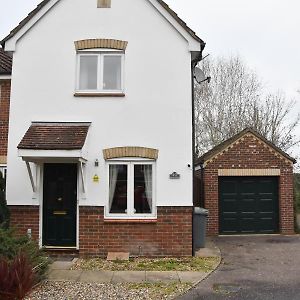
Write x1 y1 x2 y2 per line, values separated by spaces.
79 207 192 257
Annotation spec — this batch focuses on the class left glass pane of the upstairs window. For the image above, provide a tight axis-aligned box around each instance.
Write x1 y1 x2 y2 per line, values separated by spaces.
79 55 98 90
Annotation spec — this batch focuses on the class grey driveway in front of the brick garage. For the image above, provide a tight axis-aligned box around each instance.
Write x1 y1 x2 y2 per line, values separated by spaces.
178 235 300 300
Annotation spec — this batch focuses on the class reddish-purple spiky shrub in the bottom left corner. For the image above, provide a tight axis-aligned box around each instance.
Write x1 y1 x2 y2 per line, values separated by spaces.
0 253 35 300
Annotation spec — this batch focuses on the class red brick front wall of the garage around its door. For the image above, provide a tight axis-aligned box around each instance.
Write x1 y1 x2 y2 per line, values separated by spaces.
204 134 294 235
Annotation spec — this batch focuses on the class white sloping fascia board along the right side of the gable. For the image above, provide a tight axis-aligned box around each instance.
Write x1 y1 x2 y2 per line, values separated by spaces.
148 0 201 52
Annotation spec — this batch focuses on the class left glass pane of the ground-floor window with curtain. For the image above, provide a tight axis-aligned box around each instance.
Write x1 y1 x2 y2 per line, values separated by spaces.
109 165 128 214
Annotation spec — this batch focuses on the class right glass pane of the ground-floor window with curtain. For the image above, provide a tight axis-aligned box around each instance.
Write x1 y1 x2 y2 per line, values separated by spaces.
134 165 152 214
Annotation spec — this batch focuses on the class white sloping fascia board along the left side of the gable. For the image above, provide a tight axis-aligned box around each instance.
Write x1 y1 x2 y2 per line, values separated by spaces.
4 0 60 52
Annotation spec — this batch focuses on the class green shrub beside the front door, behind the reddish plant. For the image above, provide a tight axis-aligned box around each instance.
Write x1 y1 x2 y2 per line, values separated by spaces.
0 228 49 283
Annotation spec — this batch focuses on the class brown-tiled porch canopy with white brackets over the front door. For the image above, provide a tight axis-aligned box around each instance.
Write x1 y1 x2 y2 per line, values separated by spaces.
18 122 91 192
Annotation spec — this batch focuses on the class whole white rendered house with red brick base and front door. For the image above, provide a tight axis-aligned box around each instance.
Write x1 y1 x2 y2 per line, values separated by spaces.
2 0 205 256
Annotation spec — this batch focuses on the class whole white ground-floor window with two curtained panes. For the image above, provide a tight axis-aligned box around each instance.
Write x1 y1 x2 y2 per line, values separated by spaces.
105 161 156 219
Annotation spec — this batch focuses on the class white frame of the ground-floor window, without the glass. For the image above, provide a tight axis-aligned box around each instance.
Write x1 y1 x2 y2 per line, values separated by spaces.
104 159 157 220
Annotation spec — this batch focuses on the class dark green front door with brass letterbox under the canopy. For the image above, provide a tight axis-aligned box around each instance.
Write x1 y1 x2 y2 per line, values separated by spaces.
43 164 77 247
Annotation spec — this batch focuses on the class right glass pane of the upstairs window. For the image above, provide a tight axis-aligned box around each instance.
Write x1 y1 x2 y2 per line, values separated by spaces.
103 56 121 90
